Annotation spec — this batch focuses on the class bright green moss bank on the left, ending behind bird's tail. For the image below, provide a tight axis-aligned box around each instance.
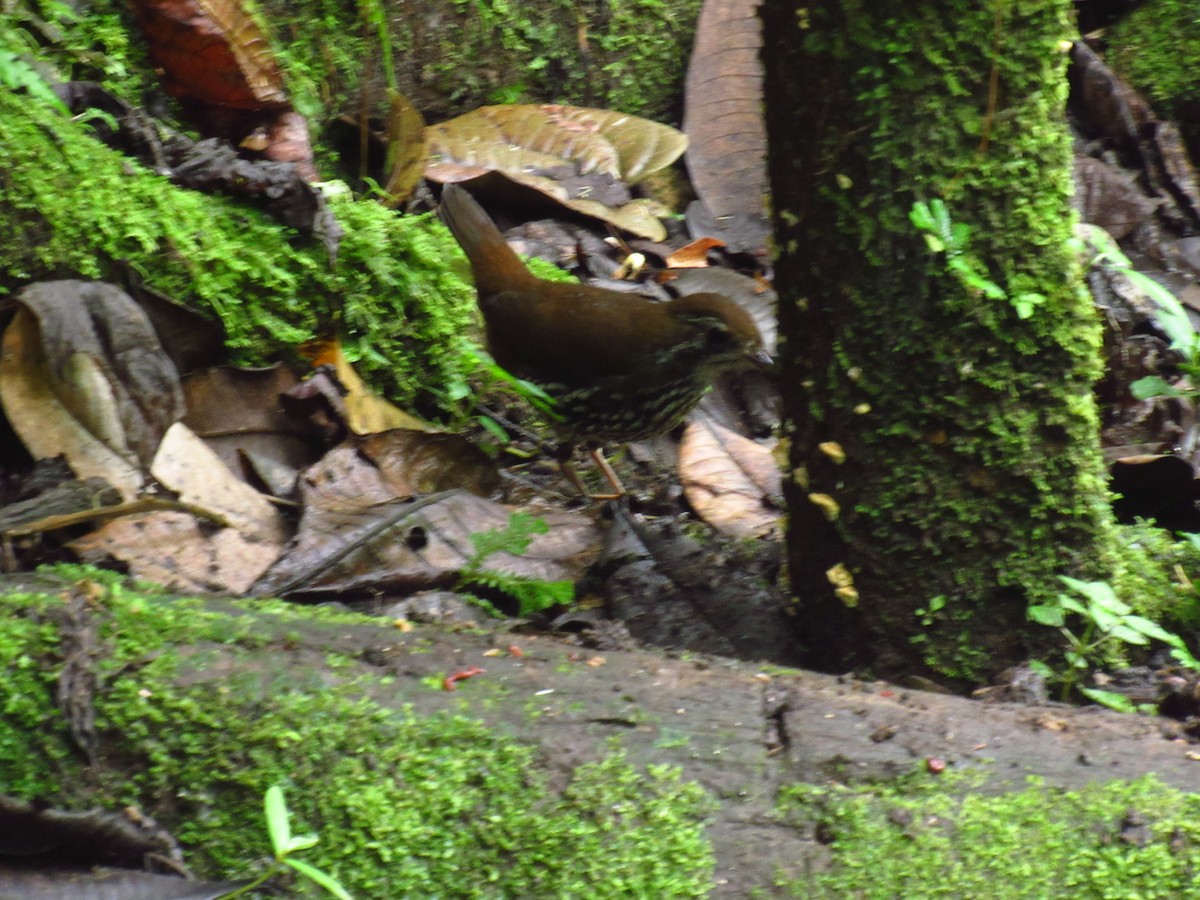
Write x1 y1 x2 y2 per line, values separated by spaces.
0 87 475 412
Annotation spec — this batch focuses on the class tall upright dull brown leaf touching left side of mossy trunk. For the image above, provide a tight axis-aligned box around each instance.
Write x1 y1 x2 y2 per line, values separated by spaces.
684 0 767 216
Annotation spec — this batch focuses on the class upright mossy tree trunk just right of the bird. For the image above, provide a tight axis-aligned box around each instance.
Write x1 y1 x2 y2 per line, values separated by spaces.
761 0 1117 679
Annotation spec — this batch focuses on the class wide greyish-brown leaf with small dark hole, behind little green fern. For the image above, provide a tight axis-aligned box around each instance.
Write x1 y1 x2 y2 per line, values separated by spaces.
253 465 599 595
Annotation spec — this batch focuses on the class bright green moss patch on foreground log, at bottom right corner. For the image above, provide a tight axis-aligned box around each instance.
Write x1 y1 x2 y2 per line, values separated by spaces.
780 775 1200 900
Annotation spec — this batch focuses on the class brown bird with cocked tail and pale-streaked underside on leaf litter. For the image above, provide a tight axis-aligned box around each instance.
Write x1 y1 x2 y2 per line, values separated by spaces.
440 184 770 494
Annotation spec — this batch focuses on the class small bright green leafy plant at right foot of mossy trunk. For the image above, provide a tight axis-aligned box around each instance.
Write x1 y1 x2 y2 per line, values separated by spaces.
1027 575 1200 713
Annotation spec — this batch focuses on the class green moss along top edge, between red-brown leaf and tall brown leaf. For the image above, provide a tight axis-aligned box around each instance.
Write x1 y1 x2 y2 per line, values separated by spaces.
263 0 701 128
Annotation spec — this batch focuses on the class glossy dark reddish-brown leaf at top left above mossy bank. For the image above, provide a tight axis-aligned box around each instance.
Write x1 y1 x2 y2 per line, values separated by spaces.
133 0 288 109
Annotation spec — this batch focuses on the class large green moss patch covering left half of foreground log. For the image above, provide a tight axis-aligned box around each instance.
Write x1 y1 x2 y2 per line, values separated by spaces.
0 570 713 896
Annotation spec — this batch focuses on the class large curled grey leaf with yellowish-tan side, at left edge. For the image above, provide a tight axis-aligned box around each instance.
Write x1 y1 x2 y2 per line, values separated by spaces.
0 281 184 499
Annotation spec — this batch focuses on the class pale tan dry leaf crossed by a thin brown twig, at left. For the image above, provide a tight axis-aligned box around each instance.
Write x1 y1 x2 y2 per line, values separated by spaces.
68 425 287 594
